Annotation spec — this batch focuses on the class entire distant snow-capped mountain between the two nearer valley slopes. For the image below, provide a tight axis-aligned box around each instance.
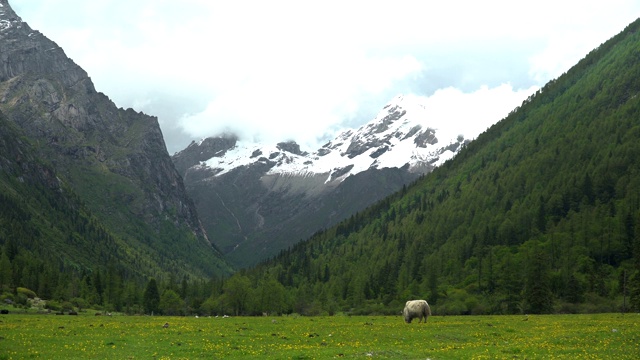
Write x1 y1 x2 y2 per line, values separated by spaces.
172 96 468 267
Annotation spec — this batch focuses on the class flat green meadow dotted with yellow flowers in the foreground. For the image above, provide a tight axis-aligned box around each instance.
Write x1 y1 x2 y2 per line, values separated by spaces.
0 314 640 359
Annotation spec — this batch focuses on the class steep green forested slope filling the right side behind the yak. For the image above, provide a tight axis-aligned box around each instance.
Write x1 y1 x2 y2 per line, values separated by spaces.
237 21 640 314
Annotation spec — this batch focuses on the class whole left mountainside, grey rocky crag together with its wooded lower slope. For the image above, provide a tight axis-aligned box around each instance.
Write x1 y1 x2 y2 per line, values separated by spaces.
0 0 231 298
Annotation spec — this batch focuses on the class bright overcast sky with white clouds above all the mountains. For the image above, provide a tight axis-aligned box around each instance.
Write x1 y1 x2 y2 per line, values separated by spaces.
10 0 640 154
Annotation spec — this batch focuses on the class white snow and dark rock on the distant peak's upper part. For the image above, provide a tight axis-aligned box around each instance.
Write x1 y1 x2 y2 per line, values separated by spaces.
200 95 464 183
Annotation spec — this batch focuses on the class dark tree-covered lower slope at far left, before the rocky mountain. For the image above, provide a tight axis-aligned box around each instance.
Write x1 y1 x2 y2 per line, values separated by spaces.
0 113 138 299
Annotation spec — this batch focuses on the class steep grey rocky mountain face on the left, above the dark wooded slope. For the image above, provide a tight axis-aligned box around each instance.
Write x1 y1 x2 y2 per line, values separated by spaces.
0 0 229 274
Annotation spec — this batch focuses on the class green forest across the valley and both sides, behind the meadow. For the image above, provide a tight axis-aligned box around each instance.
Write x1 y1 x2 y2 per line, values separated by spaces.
0 21 640 315
